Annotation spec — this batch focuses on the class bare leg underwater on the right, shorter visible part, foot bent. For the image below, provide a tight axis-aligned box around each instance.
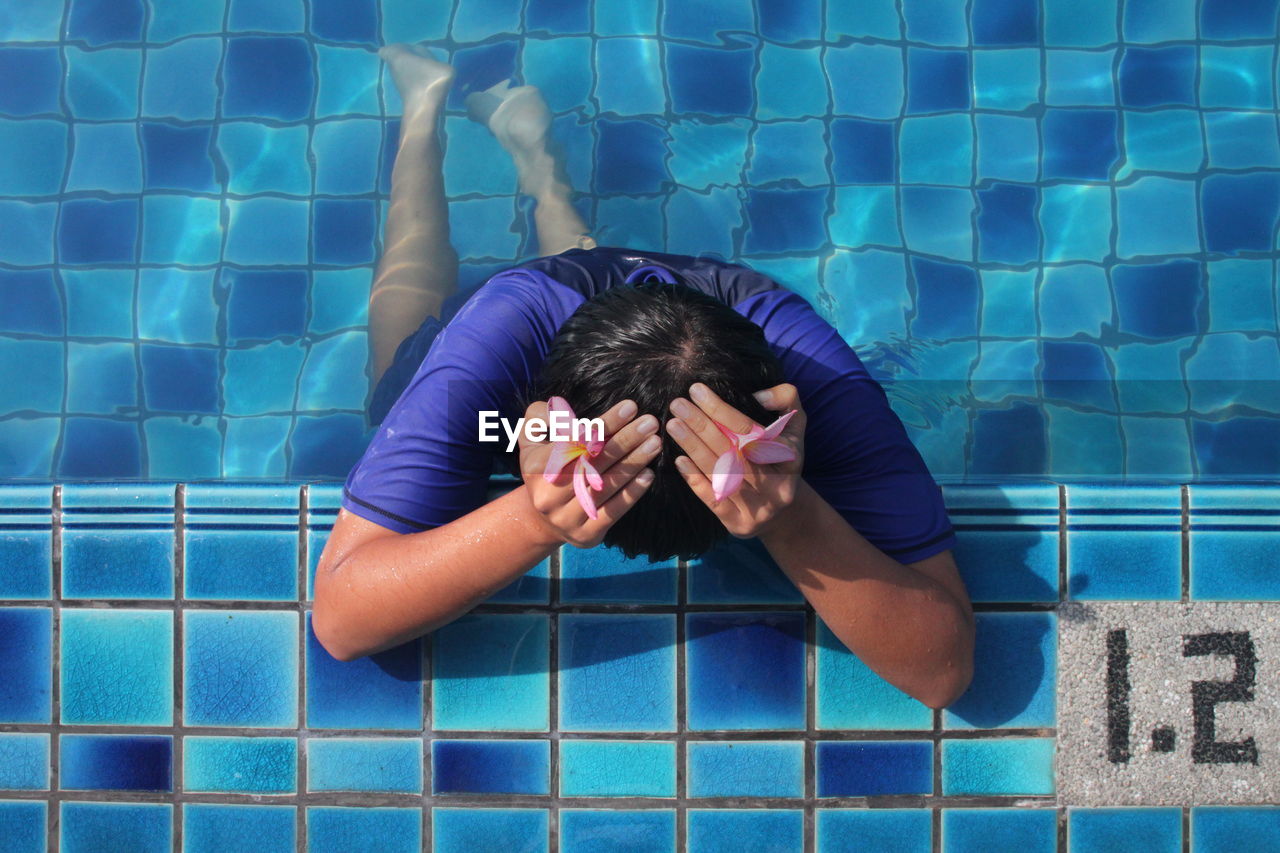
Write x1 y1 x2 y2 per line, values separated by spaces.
467 81 595 255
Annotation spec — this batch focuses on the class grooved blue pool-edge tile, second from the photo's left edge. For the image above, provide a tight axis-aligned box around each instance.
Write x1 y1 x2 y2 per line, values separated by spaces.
61 484 174 598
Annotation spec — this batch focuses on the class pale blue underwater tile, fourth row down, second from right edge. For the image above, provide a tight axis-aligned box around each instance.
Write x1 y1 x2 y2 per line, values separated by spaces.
1116 175 1201 257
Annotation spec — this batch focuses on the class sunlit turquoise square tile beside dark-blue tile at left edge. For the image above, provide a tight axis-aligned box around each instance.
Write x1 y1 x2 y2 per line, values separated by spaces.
59 608 174 726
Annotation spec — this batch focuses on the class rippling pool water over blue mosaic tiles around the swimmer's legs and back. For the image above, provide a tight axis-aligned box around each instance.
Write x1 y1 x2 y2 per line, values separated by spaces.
0 0 1280 480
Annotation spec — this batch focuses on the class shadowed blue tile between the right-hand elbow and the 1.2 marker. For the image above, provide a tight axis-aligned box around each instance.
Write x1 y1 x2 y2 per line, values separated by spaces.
942 612 1057 729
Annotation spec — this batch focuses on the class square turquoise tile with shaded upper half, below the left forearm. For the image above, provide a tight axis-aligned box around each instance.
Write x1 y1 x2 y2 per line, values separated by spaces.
431 613 547 731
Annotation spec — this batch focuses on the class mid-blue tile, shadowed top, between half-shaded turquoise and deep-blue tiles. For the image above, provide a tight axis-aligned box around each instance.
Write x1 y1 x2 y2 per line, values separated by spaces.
558 613 676 731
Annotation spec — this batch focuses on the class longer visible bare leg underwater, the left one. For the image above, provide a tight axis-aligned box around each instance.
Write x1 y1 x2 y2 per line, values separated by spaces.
369 45 458 384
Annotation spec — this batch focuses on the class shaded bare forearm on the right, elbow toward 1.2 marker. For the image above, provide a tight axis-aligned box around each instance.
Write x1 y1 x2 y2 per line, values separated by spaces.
760 480 973 707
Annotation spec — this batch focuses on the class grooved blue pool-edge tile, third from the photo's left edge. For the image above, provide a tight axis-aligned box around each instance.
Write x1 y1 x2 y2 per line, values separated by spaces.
183 484 298 601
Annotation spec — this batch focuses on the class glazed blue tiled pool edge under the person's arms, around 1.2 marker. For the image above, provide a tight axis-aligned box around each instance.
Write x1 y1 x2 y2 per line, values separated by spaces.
0 483 1280 853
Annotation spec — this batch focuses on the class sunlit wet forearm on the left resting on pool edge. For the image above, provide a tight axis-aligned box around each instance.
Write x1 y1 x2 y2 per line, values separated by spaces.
312 485 559 661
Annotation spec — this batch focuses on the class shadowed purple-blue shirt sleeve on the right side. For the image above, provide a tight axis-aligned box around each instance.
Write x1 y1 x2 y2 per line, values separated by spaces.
735 289 956 564
